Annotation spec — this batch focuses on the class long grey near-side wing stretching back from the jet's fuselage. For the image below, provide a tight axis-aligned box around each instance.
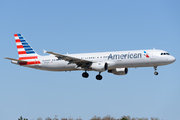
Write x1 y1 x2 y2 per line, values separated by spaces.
44 51 92 68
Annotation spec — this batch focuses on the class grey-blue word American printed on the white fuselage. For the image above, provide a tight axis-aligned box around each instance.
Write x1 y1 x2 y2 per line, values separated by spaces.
108 53 142 60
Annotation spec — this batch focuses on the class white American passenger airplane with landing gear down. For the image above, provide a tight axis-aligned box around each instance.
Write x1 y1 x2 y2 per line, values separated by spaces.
5 34 176 80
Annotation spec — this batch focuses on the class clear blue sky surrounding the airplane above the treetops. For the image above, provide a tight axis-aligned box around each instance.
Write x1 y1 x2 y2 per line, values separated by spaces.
0 0 180 120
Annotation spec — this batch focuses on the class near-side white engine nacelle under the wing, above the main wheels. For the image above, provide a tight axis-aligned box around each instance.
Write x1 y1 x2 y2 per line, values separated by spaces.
91 62 108 72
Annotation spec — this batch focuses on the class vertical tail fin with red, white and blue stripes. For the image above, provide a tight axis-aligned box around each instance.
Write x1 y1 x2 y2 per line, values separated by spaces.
14 34 39 58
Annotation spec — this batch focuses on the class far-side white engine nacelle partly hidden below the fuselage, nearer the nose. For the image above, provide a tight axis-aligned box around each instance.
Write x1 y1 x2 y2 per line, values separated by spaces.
108 68 128 75
